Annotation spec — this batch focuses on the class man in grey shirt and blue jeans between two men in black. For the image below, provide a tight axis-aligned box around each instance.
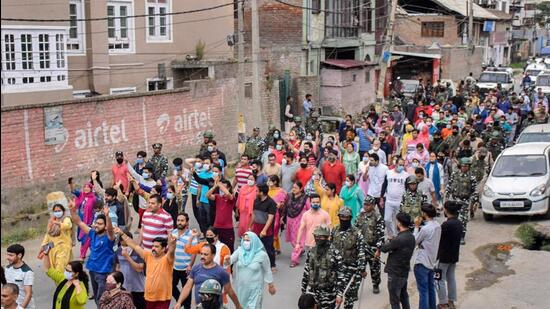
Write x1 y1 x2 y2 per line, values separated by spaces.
414 204 441 309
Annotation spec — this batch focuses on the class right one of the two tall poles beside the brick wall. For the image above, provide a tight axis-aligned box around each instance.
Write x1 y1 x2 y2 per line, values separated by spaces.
250 0 262 127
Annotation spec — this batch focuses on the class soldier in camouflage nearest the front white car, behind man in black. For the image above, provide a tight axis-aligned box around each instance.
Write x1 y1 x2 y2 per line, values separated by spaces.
445 158 478 244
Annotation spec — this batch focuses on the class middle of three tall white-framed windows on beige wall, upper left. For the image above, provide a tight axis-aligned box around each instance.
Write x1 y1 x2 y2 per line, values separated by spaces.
107 1 134 52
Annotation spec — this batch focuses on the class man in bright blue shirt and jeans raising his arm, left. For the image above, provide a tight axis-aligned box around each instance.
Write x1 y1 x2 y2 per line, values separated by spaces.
69 201 115 305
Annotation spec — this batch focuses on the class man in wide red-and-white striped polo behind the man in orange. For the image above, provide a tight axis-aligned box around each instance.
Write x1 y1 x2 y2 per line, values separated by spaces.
141 194 174 251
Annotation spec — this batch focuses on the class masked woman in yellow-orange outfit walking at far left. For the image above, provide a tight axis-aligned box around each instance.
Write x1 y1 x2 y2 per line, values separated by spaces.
40 204 73 271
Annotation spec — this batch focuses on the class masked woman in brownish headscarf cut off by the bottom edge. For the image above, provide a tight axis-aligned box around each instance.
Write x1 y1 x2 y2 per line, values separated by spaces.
99 271 135 309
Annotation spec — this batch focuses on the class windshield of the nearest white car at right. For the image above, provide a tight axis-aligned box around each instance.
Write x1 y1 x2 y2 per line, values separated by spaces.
492 155 547 177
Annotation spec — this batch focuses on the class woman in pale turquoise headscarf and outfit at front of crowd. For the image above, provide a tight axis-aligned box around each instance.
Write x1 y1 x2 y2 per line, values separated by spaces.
225 232 276 309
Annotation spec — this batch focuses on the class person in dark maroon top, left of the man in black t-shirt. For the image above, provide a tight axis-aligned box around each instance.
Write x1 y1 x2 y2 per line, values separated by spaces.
206 176 236 252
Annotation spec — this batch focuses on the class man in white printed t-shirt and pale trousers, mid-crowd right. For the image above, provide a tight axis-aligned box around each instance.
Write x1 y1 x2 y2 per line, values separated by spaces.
380 159 409 239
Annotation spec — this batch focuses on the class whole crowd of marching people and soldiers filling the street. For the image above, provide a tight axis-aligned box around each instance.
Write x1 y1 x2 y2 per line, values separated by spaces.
2 80 548 309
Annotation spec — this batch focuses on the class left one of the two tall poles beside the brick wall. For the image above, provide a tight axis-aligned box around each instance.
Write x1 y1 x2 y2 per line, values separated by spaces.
237 0 246 153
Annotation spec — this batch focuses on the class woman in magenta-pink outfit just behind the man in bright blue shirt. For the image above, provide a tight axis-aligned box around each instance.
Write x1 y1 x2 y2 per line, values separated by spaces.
73 182 97 260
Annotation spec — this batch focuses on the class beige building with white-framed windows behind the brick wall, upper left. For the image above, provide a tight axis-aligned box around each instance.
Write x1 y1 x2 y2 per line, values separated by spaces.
1 0 233 106
